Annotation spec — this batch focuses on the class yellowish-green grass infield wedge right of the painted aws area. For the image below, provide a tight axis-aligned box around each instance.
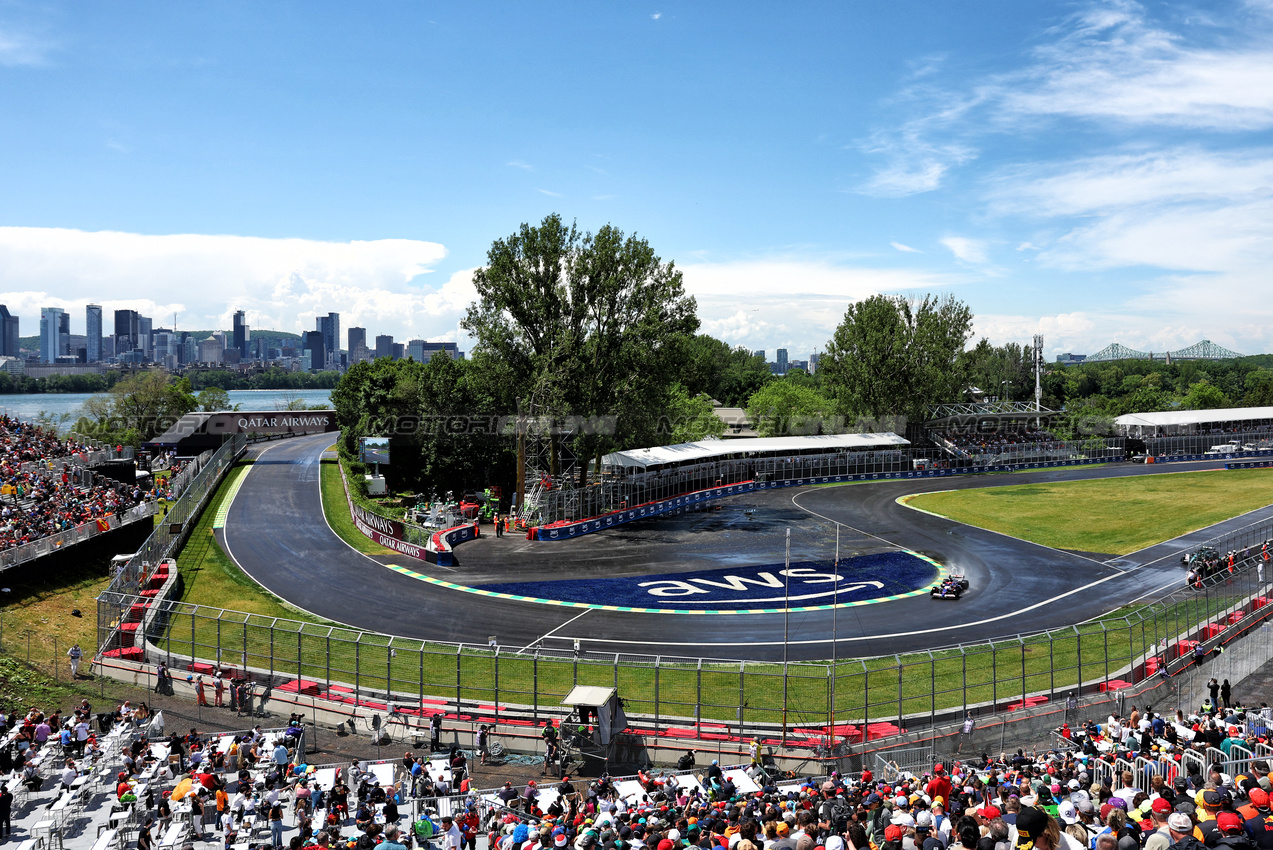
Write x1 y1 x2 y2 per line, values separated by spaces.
905 470 1273 555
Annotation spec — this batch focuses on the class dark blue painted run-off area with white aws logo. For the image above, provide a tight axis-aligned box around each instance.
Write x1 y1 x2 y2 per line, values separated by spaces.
477 552 938 610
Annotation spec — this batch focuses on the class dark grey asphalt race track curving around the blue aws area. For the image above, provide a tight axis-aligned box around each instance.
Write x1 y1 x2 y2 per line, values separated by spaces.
216 435 1273 660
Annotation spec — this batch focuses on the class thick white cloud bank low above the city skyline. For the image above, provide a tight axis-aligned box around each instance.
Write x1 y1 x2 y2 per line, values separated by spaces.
0 228 465 337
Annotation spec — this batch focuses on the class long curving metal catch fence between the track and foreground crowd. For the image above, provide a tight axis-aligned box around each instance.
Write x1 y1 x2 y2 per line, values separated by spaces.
98 511 1273 746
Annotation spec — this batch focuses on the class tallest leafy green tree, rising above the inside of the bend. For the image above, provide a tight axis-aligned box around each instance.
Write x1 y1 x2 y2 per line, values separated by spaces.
462 215 699 473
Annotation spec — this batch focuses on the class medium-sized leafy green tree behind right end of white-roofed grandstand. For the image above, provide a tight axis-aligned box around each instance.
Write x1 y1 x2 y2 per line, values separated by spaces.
819 295 973 420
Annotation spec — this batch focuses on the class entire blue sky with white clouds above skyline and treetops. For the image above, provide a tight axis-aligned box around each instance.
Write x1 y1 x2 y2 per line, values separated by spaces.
0 0 1273 358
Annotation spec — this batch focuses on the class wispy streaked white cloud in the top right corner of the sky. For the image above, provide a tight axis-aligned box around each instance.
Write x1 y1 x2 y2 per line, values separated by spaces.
857 0 1273 197
